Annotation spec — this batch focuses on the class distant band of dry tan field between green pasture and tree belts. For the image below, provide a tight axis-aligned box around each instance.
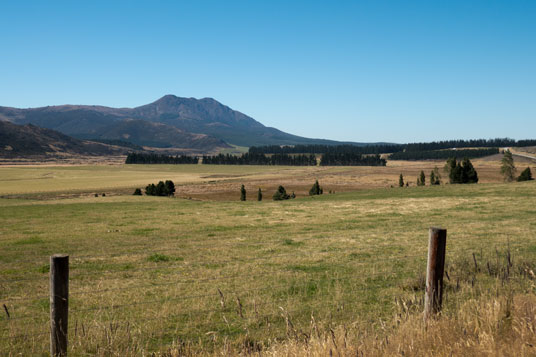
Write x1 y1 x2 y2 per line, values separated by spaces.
0 155 536 201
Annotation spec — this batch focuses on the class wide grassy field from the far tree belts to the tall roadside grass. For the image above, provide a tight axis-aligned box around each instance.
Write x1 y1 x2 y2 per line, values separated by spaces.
0 163 536 355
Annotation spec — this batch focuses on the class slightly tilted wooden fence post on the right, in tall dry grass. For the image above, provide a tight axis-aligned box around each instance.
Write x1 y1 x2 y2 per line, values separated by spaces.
424 227 447 320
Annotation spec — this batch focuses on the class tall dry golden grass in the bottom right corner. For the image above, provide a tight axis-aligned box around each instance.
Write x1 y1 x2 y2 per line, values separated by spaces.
253 294 536 357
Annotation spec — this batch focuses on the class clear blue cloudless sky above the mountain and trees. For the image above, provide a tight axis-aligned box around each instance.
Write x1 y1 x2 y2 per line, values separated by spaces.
0 0 536 142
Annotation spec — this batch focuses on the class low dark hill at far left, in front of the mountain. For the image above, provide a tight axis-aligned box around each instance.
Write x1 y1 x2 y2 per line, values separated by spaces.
0 121 129 158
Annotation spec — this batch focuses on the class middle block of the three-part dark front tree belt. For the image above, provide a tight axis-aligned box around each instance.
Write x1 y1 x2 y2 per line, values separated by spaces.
203 153 316 166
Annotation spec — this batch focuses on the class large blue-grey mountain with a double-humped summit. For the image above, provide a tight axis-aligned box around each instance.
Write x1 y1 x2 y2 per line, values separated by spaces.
0 95 362 147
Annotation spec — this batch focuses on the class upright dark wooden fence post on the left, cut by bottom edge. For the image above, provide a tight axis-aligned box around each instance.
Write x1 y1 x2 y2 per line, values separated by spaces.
50 254 69 357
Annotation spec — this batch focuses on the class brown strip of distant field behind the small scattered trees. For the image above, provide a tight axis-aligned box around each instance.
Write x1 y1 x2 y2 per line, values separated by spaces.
174 155 530 200
